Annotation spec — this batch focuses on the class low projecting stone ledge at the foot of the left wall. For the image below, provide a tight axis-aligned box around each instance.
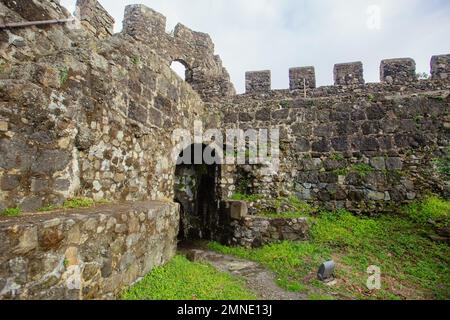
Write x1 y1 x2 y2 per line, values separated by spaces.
0 201 179 300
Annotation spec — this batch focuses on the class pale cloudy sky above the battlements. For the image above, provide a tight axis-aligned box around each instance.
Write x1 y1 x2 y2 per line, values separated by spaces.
61 0 450 92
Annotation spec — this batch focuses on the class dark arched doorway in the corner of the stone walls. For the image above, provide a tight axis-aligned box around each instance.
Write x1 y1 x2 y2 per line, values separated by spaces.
174 144 226 241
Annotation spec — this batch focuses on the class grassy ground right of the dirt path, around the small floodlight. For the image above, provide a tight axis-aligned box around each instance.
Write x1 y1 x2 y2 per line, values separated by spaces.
210 197 450 300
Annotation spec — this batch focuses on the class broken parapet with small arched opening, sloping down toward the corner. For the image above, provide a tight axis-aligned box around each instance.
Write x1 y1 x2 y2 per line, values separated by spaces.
123 5 236 101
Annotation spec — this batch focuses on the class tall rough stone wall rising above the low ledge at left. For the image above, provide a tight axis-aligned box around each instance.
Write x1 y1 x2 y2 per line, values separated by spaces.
0 1 217 211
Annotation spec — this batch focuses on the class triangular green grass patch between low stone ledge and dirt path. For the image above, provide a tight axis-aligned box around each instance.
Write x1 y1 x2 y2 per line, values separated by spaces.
122 255 256 300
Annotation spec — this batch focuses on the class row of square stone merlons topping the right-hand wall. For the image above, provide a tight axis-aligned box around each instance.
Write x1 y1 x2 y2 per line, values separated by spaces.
245 54 450 96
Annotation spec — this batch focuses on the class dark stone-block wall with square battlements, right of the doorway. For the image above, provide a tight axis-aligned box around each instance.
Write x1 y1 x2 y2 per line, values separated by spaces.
218 56 450 213
